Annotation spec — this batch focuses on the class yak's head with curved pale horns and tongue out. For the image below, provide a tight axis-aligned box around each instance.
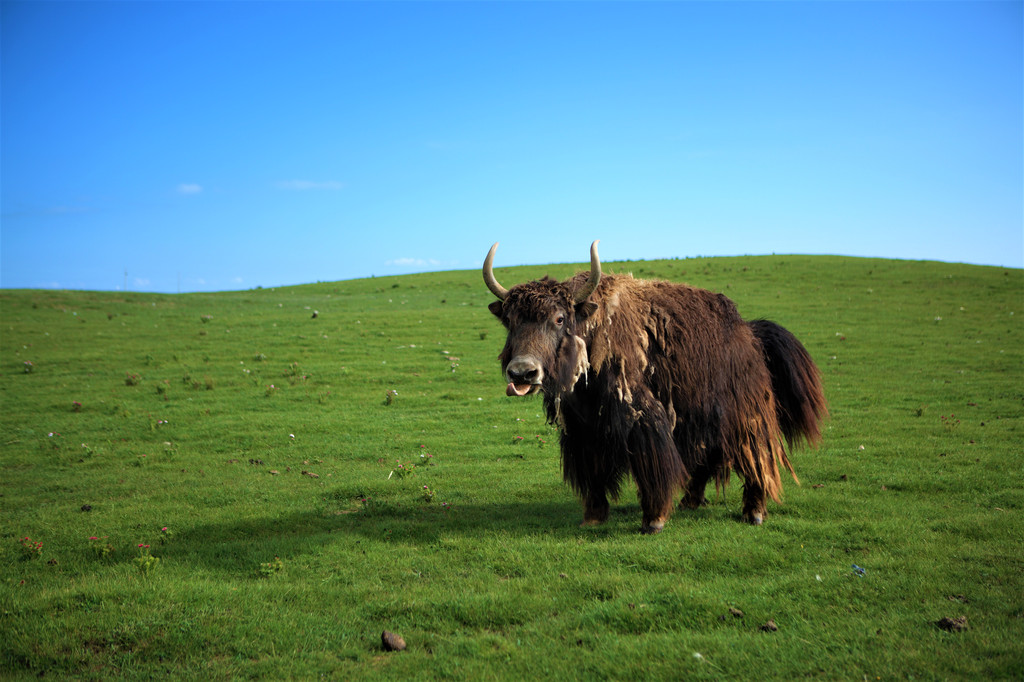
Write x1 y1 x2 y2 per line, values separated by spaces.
483 242 601 395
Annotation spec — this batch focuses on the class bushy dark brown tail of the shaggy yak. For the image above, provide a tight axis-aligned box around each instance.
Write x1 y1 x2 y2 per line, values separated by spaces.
748 319 828 450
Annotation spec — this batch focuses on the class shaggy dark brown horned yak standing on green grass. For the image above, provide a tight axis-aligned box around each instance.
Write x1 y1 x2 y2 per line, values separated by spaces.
483 242 827 534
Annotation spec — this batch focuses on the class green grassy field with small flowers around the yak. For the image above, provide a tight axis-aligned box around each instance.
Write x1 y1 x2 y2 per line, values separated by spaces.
0 251 1024 680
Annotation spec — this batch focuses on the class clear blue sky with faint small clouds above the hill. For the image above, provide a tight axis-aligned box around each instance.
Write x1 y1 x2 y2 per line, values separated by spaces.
0 1 1024 292
